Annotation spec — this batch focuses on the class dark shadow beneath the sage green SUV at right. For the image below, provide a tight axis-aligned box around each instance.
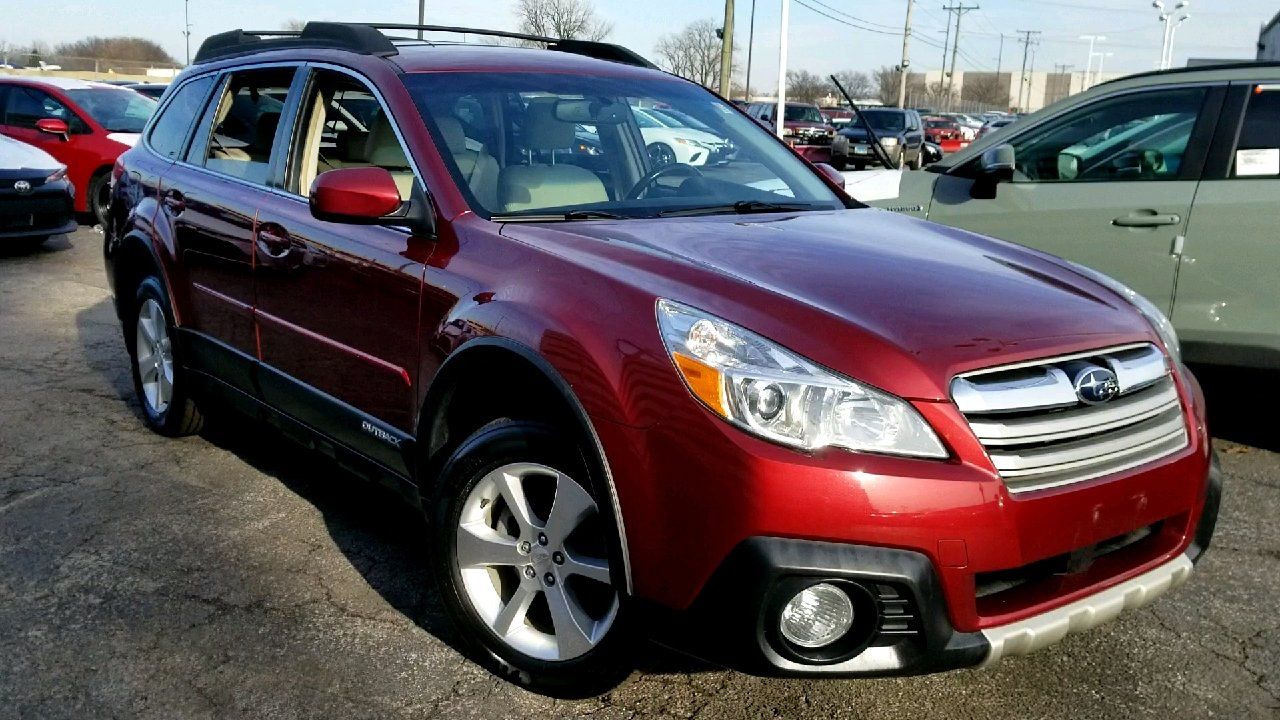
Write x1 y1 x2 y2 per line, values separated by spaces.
1192 365 1280 452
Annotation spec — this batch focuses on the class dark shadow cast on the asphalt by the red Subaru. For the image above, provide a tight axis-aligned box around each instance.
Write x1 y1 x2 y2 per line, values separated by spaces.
77 294 718 674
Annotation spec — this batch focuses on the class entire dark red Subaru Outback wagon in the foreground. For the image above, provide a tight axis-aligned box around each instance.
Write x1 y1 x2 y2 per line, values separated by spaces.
106 23 1220 694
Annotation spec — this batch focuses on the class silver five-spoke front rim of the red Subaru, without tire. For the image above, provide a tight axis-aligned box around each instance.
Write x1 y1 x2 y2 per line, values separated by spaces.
453 462 618 661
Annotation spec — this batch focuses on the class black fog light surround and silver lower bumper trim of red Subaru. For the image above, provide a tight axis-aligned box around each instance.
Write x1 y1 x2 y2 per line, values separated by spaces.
648 453 1221 676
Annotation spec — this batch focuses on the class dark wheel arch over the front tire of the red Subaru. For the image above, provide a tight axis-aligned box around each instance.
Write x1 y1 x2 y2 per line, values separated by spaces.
416 336 631 594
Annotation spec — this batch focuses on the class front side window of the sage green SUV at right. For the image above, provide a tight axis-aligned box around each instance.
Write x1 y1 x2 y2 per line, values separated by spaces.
1003 87 1206 182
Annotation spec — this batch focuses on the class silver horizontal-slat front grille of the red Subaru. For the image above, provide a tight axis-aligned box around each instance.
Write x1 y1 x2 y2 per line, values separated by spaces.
951 343 1188 493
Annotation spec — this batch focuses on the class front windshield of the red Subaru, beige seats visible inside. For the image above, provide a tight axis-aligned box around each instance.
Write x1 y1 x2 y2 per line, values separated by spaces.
404 72 845 220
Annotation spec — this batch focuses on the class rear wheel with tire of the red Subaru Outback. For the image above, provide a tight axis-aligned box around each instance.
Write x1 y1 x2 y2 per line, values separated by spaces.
125 277 204 437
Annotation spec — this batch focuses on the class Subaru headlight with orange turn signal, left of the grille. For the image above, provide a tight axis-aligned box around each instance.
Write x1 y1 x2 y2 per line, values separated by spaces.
658 300 947 457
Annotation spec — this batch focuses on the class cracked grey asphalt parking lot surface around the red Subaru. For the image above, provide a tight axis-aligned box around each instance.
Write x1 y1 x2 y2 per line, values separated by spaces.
0 229 1280 720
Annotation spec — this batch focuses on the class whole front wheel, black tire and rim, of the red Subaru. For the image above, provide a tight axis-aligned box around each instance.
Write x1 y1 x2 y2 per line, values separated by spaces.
430 420 631 697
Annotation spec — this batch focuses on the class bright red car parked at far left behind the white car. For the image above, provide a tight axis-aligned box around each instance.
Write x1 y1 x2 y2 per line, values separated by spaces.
0 76 156 225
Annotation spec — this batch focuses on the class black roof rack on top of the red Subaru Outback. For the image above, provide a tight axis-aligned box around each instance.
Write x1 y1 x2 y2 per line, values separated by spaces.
193 22 657 69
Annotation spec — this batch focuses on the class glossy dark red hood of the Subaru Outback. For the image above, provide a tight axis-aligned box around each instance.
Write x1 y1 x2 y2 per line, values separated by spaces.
503 209 1153 398
